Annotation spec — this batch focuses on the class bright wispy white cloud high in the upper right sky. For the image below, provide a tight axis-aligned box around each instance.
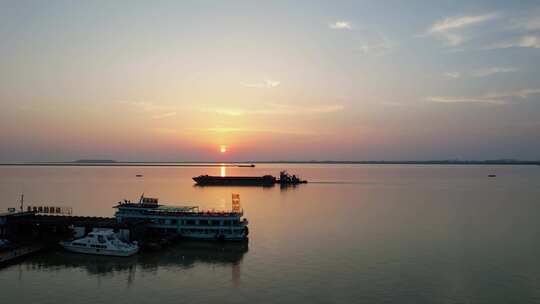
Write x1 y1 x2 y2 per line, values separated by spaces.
420 13 499 46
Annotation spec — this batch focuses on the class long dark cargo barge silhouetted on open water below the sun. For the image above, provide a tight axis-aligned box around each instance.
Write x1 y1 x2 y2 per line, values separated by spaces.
193 171 307 187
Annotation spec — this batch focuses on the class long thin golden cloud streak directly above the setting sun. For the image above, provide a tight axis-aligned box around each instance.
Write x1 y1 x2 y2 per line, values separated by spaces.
202 103 344 116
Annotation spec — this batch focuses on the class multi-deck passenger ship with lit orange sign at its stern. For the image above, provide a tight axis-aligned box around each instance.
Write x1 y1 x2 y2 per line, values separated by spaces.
114 194 249 241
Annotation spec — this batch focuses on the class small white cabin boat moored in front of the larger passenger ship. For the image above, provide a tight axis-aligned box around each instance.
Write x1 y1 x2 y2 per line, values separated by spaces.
60 230 139 256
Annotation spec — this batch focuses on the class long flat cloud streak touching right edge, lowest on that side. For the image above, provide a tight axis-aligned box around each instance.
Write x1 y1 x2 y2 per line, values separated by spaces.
426 89 540 105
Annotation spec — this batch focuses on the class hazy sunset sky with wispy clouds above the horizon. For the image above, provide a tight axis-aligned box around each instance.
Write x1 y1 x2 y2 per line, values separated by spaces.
0 1 540 162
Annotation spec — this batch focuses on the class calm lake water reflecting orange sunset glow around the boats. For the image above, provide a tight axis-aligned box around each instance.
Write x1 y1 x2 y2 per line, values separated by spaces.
0 164 540 304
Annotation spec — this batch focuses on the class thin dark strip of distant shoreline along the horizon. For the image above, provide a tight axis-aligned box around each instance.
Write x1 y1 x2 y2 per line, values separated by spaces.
0 160 540 167
